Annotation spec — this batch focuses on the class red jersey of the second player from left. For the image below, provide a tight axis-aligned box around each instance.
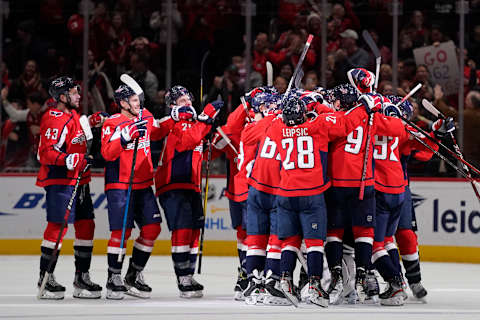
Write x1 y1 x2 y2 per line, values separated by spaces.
101 109 174 191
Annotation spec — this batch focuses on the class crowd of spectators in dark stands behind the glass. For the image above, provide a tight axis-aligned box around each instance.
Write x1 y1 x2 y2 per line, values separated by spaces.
0 0 480 175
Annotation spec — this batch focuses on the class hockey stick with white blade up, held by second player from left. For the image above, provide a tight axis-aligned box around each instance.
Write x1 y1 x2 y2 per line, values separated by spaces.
117 73 144 262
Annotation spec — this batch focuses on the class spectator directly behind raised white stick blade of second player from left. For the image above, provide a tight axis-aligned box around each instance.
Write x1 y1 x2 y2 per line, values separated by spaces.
129 53 158 106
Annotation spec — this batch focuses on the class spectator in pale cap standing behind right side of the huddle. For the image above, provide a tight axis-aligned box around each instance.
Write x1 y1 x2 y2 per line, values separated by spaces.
335 29 371 83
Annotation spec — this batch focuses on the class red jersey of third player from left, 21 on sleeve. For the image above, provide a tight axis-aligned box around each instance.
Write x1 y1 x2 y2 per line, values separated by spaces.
155 120 211 195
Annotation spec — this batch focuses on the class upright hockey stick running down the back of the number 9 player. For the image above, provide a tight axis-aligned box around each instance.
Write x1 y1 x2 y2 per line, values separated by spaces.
360 30 382 200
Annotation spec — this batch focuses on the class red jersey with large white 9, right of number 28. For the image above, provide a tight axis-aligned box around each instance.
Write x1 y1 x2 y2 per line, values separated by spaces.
328 111 405 187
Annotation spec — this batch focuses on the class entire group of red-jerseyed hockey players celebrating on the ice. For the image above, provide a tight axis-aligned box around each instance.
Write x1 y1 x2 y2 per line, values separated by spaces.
37 68 455 307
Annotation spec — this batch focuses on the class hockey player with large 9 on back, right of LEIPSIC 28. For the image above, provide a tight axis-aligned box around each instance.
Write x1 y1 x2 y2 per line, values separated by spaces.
326 87 404 303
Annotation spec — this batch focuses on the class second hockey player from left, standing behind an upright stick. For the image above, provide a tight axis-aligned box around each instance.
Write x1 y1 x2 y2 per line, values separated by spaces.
101 85 174 300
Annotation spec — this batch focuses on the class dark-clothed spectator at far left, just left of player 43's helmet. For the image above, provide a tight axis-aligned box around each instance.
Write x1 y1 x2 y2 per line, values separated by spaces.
9 60 48 105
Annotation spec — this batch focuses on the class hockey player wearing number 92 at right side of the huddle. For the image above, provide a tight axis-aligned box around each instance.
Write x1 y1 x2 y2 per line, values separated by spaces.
372 99 451 305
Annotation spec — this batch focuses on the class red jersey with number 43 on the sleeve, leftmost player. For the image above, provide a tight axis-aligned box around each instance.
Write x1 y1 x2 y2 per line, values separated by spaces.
36 109 90 187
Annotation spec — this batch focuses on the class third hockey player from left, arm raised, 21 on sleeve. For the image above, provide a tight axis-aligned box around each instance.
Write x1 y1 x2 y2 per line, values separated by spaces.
155 86 223 298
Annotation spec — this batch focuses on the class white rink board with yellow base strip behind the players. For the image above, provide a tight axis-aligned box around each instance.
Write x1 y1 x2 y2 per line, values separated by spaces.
0 175 480 263
